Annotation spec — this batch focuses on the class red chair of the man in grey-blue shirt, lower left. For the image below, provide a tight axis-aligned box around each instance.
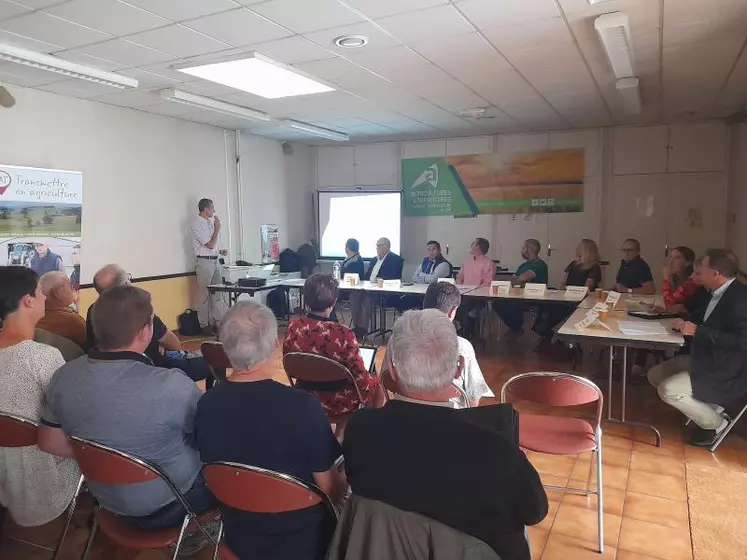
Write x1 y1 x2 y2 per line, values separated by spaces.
70 436 218 560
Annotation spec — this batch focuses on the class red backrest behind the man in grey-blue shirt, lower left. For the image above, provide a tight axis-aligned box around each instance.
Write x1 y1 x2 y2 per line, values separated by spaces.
70 436 162 485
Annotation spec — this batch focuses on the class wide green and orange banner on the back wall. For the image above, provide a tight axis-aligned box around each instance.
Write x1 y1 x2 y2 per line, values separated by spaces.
402 148 585 216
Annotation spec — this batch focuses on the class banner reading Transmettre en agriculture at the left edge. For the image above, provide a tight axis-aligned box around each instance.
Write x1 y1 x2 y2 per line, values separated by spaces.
0 164 83 294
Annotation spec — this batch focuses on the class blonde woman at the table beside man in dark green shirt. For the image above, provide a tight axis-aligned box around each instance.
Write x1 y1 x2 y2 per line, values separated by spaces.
533 239 602 342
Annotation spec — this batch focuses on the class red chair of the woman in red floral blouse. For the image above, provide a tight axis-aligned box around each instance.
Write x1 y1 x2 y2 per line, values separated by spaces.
283 352 363 437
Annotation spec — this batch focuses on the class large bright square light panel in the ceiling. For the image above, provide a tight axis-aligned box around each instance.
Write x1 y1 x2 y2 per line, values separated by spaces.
174 53 333 99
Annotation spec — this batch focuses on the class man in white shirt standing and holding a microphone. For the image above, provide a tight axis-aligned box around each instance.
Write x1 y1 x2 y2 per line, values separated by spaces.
191 198 228 334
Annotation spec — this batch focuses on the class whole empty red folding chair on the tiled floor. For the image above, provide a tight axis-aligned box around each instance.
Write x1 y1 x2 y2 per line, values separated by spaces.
501 372 604 553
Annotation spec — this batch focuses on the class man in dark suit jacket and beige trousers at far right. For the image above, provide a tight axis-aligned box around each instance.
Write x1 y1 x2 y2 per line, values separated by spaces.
648 249 747 447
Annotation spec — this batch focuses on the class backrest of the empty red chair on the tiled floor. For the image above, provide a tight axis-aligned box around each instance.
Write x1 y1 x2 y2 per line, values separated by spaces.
501 371 604 425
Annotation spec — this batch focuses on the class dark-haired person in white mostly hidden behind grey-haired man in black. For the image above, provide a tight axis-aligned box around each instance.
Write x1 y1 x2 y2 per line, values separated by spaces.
382 282 495 406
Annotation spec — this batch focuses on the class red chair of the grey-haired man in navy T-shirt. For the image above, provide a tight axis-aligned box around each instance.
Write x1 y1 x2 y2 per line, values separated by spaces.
204 462 338 560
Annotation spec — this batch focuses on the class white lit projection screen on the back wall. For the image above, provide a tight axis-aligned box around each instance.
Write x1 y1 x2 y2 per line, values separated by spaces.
317 191 402 258
